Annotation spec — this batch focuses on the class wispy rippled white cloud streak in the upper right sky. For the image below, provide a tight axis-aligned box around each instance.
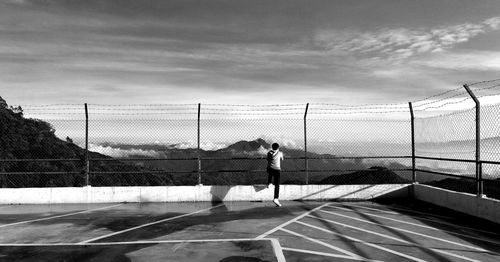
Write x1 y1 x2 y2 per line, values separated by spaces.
316 17 500 60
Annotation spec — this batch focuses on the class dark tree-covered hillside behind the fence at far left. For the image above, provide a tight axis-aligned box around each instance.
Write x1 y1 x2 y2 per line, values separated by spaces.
0 97 173 187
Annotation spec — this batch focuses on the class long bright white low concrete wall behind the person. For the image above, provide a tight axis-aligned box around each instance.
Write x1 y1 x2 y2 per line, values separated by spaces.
0 184 410 204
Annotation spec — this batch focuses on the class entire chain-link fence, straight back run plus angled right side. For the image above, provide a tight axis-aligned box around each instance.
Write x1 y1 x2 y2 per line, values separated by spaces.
0 80 500 201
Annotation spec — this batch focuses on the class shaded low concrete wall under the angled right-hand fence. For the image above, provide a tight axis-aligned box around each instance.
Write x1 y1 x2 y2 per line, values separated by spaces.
415 185 500 224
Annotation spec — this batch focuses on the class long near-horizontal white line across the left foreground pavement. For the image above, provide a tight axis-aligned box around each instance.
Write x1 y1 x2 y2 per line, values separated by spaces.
0 238 273 247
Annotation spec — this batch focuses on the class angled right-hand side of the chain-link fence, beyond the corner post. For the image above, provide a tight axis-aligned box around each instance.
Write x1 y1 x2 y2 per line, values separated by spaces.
413 80 500 198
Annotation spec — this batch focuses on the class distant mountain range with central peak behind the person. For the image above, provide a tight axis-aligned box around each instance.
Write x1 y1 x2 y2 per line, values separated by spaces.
98 138 409 185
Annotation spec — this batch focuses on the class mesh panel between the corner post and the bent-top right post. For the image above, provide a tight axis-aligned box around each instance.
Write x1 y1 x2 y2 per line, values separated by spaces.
413 87 476 193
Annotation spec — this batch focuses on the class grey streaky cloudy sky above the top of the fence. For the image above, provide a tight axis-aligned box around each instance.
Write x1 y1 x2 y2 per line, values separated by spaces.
0 0 500 105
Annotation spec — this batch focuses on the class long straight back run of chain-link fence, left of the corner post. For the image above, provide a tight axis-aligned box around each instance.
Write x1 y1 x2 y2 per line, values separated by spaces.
1 104 411 187
